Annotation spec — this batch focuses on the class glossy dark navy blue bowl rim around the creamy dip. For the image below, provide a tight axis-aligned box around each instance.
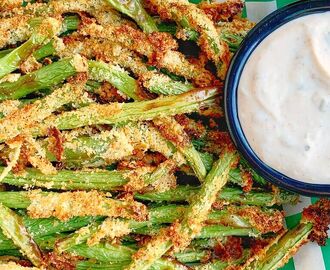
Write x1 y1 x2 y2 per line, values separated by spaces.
224 0 330 196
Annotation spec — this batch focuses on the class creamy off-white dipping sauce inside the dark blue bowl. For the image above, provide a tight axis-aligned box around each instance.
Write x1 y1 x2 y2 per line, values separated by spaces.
237 12 330 184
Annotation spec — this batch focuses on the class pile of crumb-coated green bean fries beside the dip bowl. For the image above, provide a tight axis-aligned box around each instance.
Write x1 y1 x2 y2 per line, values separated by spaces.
0 0 330 270
